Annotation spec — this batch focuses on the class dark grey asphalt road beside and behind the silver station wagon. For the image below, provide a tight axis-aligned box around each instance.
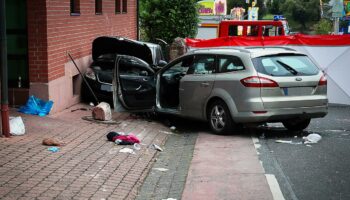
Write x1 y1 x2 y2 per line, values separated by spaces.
253 107 350 200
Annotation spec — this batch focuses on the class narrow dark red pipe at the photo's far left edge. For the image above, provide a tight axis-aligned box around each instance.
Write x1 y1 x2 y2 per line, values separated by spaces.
0 0 10 137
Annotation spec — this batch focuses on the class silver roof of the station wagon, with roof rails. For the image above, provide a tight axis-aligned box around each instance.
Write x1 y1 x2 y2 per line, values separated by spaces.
188 47 305 58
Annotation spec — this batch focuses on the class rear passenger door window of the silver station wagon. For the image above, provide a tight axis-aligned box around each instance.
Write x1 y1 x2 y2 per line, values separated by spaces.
187 55 215 74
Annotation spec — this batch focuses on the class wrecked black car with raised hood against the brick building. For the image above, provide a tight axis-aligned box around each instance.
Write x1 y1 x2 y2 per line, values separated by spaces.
81 36 167 104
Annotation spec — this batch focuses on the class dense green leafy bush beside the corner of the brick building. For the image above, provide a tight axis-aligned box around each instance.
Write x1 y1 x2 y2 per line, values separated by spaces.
140 0 198 43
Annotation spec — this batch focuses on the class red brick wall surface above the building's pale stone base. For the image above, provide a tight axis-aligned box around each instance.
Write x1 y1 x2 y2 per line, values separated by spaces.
27 0 137 83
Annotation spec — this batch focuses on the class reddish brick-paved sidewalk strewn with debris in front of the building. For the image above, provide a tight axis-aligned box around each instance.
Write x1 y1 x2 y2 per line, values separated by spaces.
0 104 169 199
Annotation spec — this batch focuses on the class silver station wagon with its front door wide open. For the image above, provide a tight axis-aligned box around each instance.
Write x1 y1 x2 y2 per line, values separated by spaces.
113 47 328 134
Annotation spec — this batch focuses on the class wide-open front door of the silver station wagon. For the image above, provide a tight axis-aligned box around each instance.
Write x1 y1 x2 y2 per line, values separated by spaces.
113 55 156 112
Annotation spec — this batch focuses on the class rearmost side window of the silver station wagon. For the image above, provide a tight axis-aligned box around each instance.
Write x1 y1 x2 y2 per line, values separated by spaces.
218 56 245 72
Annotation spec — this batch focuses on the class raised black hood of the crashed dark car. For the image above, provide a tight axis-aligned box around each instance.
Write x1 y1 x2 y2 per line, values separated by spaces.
92 36 153 65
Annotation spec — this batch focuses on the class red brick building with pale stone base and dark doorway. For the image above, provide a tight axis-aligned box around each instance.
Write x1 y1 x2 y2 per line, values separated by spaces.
6 0 138 112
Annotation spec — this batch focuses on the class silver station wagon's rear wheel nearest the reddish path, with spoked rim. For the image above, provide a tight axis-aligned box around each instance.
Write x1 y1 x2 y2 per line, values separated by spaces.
208 100 235 135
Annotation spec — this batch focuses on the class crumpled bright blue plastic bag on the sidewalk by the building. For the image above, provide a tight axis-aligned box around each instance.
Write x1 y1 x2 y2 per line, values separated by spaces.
19 95 53 117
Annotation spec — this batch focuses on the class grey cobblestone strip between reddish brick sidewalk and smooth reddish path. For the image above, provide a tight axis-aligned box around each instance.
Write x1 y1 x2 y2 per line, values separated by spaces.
136 133 198 200
